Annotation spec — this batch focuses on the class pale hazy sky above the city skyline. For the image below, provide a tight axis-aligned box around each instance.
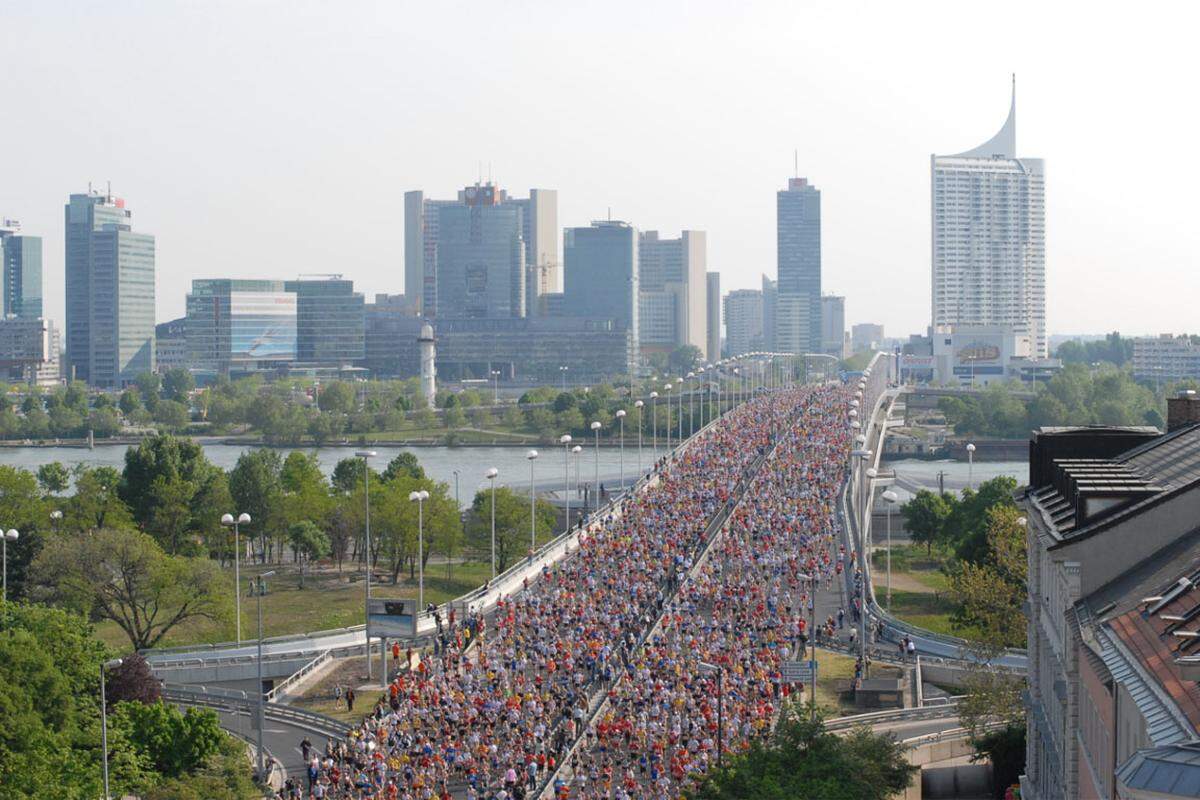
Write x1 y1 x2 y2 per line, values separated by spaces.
0 0 1200 335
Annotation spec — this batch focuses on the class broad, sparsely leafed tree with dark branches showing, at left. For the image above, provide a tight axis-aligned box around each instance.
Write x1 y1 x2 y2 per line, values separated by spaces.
32 529 230 650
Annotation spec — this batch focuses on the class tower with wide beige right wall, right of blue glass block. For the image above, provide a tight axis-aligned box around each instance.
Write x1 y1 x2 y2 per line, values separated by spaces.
637 230 708 354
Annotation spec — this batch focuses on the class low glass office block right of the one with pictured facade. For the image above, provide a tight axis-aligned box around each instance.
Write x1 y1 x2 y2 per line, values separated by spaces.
283 275 366 367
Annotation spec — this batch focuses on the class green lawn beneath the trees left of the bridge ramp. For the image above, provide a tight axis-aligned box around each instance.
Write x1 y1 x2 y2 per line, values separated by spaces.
96 561 501 649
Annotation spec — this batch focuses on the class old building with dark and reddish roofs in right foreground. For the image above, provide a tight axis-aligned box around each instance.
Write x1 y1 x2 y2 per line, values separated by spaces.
1021 395 1200 800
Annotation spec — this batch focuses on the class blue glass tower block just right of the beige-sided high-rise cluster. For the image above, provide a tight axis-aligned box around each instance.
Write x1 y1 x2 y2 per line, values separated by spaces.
563 219 640 353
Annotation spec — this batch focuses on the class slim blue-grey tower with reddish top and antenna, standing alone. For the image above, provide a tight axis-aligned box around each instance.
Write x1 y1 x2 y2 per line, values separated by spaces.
772 178 821 353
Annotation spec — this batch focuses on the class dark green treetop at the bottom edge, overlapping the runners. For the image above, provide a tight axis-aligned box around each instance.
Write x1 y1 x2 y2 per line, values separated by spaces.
688 706 919 800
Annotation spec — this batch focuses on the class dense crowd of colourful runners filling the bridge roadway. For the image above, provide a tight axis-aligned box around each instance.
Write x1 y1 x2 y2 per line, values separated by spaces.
296 386 853 800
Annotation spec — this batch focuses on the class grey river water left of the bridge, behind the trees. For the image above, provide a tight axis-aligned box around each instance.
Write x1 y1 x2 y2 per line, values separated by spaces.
0 444 654 507
